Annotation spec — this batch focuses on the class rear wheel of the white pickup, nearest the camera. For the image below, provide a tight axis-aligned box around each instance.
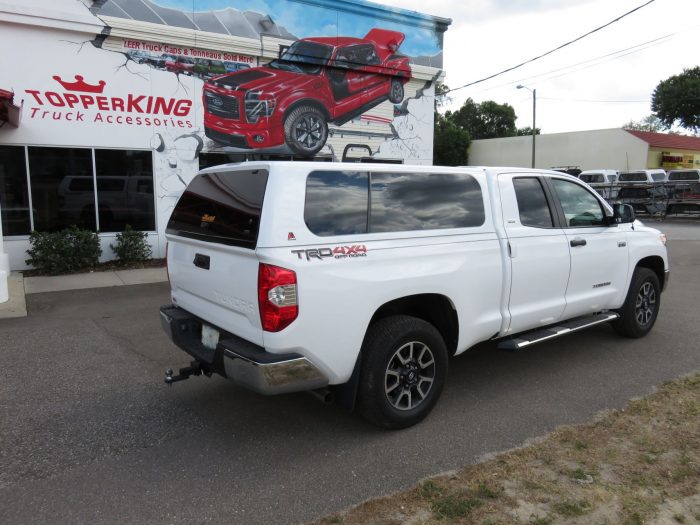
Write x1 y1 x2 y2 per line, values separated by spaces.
357 315 447 429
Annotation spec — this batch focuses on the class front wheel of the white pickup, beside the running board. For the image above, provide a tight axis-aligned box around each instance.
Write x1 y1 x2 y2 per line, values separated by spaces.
613 267 661 338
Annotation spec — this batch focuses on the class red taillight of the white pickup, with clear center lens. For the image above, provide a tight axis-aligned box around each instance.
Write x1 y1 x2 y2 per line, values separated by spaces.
258 263 299 332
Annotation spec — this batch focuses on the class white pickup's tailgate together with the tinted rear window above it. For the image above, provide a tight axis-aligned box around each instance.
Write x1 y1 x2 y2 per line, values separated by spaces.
166 166 268 346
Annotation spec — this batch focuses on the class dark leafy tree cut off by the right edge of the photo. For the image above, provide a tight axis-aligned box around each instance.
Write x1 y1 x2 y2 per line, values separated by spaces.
651 66 700 133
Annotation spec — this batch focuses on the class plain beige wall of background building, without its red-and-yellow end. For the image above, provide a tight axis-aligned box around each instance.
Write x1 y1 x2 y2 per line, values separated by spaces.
469 128 649 170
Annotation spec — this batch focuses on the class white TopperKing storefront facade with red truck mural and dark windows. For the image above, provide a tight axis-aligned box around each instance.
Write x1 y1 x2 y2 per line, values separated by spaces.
0 0 450 270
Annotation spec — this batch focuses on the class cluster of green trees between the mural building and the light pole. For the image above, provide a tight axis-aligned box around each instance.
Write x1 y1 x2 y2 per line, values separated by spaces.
445 98 517 140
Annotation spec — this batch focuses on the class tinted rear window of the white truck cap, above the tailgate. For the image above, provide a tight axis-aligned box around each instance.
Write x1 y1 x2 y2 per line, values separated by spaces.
166 170 268 248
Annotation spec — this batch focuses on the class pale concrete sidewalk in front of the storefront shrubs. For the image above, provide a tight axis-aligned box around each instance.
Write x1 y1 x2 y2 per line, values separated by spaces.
0 268 168 319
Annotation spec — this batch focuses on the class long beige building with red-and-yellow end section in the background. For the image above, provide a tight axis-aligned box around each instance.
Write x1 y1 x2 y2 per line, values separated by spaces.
469 128 700 170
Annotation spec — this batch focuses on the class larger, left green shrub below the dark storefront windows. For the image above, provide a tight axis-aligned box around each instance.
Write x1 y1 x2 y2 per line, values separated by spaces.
25 226 102 275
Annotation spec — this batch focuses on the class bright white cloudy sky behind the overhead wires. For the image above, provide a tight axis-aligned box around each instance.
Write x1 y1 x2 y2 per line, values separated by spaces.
381 0 700 133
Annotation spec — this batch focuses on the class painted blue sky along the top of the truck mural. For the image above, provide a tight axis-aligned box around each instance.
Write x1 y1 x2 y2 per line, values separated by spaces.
152 0 441 56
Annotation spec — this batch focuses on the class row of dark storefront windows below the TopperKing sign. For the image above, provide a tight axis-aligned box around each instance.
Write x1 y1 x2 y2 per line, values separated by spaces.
0 146 156 236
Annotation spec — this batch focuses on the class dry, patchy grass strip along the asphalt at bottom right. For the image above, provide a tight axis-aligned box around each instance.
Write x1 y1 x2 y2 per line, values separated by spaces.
318 374 700 525
